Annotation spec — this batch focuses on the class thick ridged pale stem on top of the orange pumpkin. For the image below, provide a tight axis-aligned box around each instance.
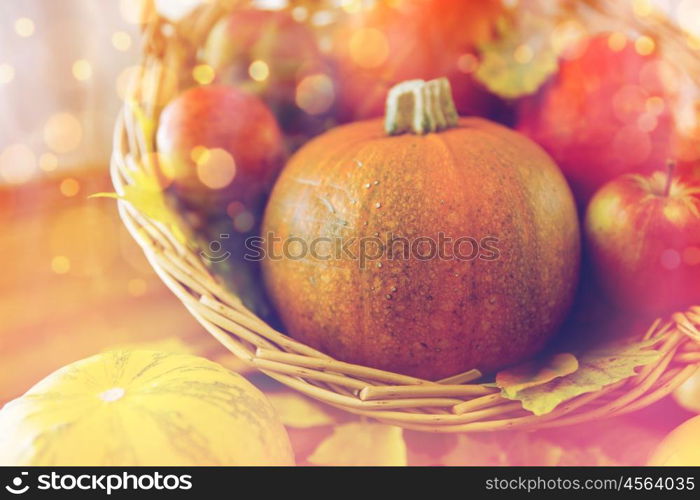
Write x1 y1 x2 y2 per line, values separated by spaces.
384 77 459 135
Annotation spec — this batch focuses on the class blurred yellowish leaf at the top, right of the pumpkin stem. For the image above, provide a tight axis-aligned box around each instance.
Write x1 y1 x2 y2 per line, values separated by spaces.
475 11 559 99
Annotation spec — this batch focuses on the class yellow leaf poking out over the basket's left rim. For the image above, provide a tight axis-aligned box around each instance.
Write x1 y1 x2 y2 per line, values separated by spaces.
90 170 187 243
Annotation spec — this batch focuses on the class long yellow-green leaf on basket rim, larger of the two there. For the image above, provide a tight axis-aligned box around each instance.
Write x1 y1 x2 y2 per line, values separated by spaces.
503 341 660 415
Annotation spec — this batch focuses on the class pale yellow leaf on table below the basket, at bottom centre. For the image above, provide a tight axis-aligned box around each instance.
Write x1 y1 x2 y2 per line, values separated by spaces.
308 422 406 466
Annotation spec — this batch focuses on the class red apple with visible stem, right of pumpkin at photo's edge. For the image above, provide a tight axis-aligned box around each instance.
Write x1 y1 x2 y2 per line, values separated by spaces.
585 162 700 314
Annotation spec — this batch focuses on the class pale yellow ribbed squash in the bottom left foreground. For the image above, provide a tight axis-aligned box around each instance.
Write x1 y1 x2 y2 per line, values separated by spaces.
0 351 294 466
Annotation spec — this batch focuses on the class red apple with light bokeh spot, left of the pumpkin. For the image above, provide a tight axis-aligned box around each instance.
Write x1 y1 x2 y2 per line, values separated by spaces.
157 85 285 214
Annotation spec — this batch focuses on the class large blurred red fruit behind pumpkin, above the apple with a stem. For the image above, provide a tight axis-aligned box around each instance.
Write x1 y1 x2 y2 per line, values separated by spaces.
517 36 673 206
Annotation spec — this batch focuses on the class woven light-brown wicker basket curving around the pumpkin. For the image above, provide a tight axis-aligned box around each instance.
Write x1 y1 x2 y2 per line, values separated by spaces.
111 0 700 432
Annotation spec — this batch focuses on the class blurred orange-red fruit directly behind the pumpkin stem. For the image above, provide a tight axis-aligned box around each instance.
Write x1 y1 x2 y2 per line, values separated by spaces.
331 0 503 121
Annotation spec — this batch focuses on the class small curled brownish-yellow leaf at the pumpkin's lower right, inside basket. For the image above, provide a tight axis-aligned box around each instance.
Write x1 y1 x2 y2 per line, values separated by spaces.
496 353 578 399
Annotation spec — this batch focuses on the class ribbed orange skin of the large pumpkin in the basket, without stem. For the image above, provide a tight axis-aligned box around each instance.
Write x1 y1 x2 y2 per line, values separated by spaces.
262 118 580 380
